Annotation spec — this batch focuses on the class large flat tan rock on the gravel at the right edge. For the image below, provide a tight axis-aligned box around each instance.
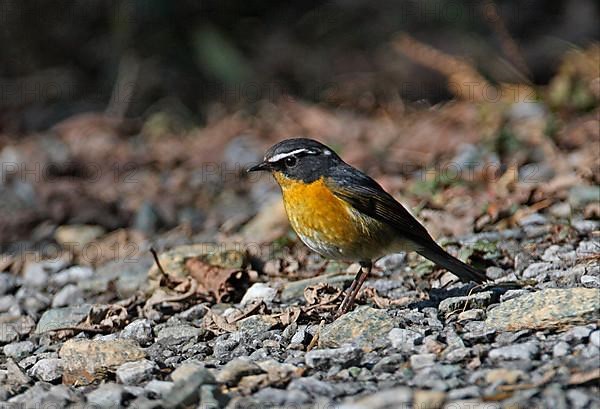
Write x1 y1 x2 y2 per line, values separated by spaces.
485 288 600 331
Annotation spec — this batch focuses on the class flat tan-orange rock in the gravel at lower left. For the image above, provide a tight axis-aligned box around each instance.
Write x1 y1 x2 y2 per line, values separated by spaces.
59 339 146 385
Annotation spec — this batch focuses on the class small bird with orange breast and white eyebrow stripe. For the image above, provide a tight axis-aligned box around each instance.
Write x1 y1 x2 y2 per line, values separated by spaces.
248 138 487 316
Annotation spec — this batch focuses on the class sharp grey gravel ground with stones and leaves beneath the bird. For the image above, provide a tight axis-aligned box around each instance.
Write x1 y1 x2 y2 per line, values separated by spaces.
0 214 600 409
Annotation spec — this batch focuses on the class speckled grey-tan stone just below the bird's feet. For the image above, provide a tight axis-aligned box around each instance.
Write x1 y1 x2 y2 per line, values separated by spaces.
319 306 395 351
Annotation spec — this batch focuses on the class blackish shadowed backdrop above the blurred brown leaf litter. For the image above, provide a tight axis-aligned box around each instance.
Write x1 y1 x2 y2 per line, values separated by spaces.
0 0 599 131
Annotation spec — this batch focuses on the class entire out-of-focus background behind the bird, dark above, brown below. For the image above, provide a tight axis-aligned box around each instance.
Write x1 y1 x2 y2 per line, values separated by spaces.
0 0 600 251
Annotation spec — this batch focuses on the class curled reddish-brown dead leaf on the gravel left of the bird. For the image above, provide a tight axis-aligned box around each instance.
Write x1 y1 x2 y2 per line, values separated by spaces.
185 257 250 302
